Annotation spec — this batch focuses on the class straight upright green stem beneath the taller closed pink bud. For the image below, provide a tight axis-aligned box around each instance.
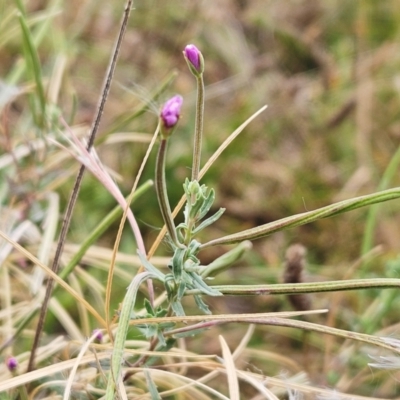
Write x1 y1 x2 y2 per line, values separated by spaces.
192 74 204 181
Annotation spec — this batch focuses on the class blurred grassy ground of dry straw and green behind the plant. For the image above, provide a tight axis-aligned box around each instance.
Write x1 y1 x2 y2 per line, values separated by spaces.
0 0 400 399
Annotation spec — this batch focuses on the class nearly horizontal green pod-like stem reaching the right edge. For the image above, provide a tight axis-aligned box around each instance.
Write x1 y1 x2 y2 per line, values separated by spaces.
185 278 400 296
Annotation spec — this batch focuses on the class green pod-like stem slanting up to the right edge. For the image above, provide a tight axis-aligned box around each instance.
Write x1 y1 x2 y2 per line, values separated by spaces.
201 187 400 248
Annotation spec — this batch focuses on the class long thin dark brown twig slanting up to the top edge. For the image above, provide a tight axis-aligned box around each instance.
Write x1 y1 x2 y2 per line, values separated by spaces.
28 0 133 372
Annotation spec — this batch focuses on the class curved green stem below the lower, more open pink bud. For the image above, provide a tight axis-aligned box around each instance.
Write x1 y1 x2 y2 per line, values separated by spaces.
156 137 183 248
